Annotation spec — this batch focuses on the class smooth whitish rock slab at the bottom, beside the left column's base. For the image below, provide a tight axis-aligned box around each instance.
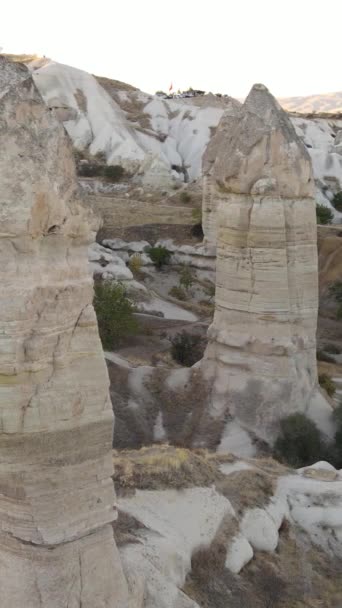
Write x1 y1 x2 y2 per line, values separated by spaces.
118 488 235 608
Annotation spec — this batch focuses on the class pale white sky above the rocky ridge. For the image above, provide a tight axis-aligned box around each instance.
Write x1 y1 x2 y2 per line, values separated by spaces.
0 0 342 97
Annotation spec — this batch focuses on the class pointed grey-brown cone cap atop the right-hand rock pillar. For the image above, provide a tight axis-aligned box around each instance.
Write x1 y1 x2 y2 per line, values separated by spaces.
213 84 314 199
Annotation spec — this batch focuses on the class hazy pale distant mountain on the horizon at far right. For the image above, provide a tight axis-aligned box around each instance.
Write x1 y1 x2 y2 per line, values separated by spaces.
278 91 342 114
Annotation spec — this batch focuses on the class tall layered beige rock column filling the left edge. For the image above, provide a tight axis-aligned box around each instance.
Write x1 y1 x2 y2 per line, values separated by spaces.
0 58 129 608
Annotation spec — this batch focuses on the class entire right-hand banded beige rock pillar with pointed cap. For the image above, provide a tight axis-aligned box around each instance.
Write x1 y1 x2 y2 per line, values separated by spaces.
202 85 330 448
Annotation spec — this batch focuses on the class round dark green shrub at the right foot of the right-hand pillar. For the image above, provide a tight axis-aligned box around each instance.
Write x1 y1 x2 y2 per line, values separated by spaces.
274 414 325 467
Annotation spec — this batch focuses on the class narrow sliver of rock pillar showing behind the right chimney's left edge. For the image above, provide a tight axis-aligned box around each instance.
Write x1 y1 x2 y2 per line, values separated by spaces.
202 98 242 247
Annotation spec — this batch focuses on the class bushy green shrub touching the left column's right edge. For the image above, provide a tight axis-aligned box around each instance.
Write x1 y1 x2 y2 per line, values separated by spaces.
94 281 139 349
